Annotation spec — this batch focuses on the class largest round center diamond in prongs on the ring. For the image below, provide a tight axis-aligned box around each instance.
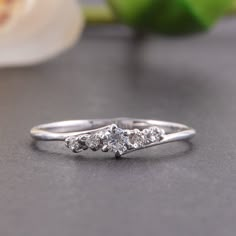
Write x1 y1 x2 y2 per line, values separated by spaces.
107 125 128 157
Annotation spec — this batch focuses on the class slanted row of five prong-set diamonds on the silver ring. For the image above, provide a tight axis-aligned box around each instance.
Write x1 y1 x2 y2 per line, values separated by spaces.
65 124 164 157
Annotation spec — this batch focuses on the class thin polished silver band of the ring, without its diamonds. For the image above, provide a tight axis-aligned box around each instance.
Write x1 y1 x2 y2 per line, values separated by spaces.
30 118 196 157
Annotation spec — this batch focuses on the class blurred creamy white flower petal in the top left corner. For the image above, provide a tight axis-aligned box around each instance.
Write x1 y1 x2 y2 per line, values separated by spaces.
0 0 83 67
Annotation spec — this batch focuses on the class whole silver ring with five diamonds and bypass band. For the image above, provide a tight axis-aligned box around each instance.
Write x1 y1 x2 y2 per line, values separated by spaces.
30 118 196 157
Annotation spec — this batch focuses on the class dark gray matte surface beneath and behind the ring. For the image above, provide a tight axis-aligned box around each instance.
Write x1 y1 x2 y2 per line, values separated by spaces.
0 20 236 236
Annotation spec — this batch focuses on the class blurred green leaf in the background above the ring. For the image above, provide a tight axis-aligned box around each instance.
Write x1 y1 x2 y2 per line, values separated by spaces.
107 0 233 34
